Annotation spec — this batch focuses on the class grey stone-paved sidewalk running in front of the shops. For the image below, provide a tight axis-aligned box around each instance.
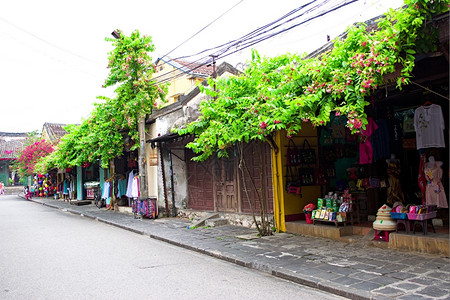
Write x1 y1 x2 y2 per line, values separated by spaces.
19 195 450 299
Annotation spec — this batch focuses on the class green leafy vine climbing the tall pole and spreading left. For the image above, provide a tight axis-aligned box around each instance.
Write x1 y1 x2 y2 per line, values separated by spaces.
42 31 167 168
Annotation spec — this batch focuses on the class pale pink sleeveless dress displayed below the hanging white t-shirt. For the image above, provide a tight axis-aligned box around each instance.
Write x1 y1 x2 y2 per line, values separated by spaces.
425 162 448 208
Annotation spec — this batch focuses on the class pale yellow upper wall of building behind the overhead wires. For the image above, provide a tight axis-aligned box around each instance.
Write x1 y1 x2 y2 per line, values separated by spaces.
153 60 203 105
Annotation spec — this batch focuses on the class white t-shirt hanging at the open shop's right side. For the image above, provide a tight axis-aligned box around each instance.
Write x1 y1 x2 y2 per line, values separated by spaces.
414 104 445 149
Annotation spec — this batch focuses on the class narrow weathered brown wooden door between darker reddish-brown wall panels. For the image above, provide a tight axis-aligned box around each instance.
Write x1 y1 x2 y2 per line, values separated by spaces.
214 155 237 212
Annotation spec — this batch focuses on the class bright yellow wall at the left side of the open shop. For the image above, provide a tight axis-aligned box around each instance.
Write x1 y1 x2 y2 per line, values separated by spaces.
273 123 321 231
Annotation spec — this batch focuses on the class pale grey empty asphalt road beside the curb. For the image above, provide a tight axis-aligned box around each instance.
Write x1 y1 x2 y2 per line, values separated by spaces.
0 196 343 300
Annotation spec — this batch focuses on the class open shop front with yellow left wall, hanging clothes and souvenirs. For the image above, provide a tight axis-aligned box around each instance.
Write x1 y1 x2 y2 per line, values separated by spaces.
275 48 449 251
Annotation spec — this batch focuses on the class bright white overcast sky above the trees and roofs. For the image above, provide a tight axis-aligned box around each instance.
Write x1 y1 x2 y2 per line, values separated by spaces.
0 0 403 132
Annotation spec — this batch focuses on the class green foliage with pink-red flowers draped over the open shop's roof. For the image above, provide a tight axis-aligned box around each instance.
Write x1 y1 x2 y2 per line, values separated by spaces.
176 0 448 161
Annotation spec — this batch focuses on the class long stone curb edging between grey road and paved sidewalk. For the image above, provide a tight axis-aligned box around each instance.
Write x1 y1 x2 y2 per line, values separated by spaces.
17 194 373 300
